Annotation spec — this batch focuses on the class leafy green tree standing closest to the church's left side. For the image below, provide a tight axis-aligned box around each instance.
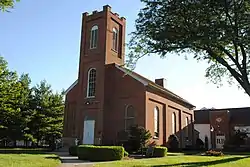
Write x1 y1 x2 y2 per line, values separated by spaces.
29 81 64 146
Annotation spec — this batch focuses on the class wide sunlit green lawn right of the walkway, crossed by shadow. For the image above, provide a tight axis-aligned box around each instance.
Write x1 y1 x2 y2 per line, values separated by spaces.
95 154 250 167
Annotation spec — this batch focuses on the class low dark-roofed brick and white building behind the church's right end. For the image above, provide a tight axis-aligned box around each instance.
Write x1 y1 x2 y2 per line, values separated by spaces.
194 107 250 149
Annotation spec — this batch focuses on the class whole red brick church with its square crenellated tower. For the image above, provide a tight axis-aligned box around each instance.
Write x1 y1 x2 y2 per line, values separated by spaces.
63 5 194 147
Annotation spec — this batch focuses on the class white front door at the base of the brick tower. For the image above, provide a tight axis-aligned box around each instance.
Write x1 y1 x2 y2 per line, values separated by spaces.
82 120 95 144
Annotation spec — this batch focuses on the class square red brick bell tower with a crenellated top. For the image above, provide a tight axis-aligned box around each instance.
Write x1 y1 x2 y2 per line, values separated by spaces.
77 5 126 144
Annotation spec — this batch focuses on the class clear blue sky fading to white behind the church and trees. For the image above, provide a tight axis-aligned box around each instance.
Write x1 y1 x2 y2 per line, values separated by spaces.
0 0 249 109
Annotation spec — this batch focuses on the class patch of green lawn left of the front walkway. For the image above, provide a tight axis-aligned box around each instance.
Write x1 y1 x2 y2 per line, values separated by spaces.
0 154 60 167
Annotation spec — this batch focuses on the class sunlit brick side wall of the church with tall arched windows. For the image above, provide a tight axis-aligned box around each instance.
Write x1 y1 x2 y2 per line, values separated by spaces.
145 89 194 147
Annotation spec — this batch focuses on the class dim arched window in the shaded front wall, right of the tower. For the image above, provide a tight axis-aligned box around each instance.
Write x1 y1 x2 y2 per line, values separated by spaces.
125 105 135 131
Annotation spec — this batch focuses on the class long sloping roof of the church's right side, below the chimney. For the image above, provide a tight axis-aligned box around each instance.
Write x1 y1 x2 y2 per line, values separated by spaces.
115 64 195 108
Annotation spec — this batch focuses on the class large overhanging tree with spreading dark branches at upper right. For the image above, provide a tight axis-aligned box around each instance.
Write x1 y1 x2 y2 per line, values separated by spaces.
128 0 250 96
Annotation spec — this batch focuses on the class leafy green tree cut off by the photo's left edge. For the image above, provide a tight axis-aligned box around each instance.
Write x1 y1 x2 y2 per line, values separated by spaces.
0 57 23 145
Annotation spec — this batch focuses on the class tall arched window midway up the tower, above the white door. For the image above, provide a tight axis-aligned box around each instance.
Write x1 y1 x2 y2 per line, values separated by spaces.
87 68 96 97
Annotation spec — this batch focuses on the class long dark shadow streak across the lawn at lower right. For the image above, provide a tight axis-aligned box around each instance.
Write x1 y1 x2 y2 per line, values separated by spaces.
153 156 249 167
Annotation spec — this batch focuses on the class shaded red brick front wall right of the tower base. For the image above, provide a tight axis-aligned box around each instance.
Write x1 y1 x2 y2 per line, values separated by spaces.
104 64 145 142
